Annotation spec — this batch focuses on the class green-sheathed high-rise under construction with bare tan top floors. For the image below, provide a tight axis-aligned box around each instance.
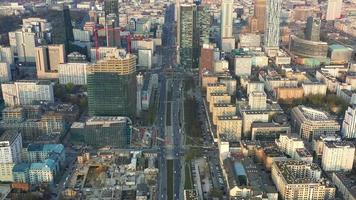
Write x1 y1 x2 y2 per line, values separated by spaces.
87 54 137 117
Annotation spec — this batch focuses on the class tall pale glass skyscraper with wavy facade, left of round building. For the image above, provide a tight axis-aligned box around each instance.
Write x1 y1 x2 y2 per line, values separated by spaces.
264 0 282 54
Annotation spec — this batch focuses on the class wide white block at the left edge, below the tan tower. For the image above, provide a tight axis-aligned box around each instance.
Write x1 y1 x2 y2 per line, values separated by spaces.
1 81 54 106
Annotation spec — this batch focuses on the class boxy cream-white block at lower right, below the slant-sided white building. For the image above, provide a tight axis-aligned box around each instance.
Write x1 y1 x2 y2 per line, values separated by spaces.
321 141 355 171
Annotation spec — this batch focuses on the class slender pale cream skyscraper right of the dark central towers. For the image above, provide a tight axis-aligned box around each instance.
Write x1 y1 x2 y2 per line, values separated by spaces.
220 0 234 38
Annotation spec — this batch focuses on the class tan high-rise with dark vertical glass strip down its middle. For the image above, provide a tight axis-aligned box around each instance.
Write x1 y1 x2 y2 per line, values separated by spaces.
35 44 66 79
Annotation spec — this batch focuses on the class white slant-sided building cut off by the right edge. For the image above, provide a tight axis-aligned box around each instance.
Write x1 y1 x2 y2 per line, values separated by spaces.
341 104 356 138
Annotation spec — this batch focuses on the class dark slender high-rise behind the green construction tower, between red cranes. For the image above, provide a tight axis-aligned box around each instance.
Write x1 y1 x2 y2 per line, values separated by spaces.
105 13 121 47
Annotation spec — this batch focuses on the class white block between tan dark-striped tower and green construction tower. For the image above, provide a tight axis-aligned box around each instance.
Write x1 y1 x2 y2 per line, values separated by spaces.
58 63 89 85
